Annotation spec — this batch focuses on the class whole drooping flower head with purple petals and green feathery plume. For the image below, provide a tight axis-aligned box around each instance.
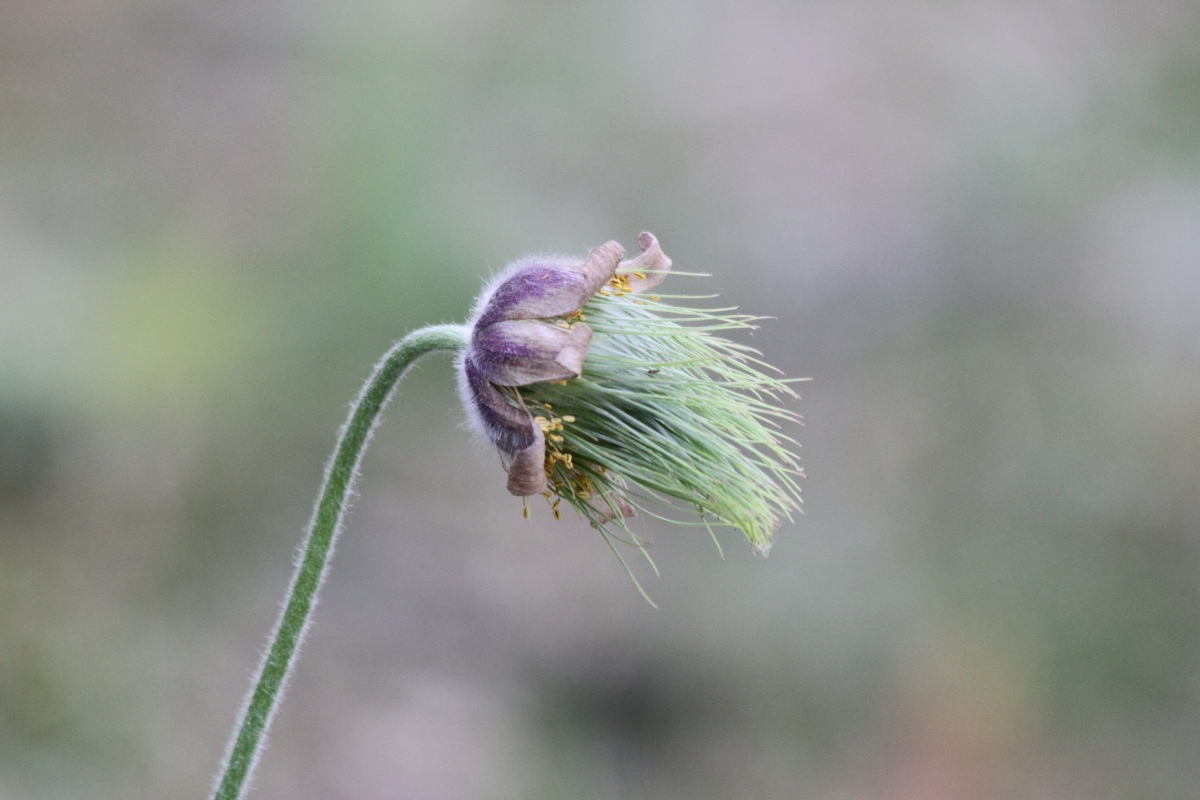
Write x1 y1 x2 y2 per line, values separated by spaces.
458 233 803 554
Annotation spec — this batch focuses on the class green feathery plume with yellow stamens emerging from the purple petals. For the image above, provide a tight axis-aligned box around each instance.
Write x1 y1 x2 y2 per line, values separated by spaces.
509 271 804 566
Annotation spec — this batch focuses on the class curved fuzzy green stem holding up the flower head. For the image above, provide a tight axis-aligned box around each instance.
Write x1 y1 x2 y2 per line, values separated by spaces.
212 325 467 800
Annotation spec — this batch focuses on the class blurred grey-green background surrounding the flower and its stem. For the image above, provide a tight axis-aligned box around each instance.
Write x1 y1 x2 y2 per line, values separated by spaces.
0 0 1200 800
